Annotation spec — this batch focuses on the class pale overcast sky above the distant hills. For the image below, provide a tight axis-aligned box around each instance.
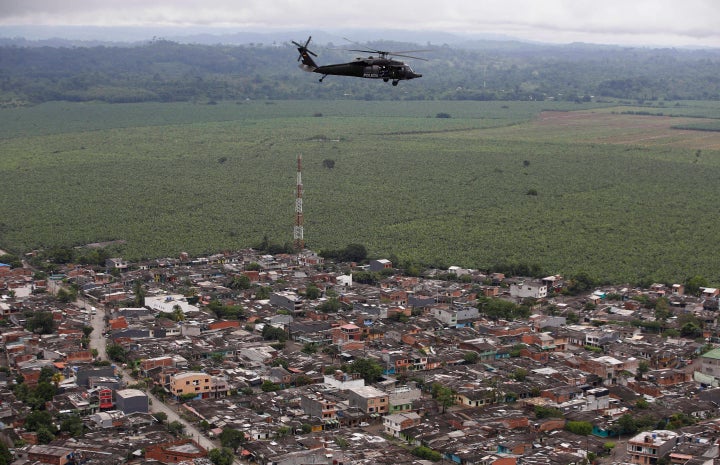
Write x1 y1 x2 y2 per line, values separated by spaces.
0 0 720 47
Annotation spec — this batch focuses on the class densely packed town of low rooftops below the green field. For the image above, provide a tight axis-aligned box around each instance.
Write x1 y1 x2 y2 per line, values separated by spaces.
0 249 720 465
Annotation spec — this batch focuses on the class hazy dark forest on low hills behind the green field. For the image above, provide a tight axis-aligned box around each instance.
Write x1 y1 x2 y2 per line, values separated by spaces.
0 39 720 106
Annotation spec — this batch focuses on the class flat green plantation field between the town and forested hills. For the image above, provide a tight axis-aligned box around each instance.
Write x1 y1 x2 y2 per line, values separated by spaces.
0 101 720 283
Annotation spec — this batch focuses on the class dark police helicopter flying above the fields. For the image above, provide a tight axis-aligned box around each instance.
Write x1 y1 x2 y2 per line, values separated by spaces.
292 36 427 86
